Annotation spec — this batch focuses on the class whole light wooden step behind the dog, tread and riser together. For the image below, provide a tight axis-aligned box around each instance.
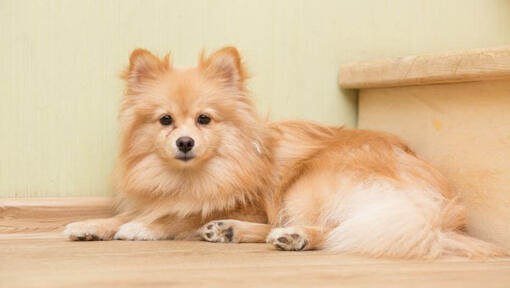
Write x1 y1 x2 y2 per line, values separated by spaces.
339 46 510 248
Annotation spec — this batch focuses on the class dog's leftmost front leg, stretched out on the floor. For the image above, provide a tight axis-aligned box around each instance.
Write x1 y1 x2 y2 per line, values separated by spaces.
64 216 128 241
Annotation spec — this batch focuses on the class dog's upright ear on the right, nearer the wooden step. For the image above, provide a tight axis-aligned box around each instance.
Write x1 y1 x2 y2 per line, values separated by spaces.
200 47 247 88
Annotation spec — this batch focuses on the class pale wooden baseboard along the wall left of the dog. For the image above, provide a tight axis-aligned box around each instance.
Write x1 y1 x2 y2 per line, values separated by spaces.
0 197 113 239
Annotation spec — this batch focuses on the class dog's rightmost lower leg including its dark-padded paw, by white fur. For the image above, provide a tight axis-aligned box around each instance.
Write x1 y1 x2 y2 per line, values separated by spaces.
266 226 326 251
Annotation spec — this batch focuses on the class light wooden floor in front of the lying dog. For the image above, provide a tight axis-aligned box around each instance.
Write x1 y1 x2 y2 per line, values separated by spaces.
0 233 510 288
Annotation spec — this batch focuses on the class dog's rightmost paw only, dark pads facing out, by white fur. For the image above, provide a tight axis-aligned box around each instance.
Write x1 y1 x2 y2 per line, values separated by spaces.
266 228 308 251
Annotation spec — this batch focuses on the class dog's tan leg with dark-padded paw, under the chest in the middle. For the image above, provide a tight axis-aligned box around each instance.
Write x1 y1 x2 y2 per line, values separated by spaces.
198 219 272 243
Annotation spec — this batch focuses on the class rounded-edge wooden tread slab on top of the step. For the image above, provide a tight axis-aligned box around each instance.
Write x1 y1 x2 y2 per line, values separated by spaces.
339 46 510 89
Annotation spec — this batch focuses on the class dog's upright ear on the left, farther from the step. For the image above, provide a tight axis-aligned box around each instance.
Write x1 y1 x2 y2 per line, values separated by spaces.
121 48 170 83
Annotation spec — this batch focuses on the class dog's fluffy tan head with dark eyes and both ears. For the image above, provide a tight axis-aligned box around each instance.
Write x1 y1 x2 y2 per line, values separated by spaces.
119 47 260 176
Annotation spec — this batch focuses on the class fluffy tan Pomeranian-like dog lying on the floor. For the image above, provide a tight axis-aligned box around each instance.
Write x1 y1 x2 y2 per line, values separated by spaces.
65 47 503 258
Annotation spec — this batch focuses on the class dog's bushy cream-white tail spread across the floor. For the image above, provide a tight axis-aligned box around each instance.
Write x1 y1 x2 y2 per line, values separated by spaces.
325 198 509 259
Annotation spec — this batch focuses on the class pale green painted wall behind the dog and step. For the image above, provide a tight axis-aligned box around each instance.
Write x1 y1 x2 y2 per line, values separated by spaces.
0 0 510 197
